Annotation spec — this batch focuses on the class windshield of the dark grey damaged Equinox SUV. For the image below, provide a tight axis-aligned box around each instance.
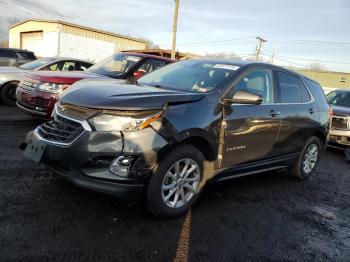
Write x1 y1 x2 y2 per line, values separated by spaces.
137 60 239 93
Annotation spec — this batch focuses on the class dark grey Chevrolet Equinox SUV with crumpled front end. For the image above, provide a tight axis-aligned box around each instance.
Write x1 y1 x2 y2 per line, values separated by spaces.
23 60 331 217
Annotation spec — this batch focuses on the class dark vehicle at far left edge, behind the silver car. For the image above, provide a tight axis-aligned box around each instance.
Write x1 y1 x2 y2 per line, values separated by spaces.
0 48 36 66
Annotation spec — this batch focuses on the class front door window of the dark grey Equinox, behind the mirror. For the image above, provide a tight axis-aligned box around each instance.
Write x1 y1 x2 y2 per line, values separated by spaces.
232 69 273 103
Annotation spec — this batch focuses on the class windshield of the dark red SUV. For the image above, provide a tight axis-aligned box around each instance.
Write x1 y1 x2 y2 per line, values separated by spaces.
87 54 141 77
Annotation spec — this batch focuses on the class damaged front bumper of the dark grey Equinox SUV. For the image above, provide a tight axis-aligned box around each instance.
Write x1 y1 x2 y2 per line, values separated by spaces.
24 123 167 202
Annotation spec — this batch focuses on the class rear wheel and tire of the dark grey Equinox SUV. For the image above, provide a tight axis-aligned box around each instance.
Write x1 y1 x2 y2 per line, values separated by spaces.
290 136 322 180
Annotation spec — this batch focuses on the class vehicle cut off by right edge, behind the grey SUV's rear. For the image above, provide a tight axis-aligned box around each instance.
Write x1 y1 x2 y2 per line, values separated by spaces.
327 89 350 147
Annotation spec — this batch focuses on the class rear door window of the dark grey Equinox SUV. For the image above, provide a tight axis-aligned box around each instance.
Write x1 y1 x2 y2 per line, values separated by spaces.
277 72 302 103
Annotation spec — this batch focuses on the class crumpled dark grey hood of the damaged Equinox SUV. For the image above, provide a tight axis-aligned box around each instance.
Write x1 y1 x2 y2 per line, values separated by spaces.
59 79 204 110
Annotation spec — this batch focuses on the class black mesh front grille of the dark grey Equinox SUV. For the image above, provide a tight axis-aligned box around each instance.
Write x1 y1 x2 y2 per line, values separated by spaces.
37 114 84 144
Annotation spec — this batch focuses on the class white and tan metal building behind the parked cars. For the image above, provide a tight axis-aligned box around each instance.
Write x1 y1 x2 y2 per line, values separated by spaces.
9 19 146 62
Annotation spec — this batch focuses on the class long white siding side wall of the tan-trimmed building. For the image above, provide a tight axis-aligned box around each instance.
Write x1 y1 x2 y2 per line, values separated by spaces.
57 33 115 62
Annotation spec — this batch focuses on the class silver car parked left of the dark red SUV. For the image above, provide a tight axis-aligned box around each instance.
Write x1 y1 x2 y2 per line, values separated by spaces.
0 58 93 106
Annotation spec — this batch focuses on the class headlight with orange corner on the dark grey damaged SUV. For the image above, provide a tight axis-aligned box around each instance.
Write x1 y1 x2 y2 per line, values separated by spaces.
89 113 161 132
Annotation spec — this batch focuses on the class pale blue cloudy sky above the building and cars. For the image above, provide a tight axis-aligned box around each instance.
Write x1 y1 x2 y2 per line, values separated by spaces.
0 0 350 72
